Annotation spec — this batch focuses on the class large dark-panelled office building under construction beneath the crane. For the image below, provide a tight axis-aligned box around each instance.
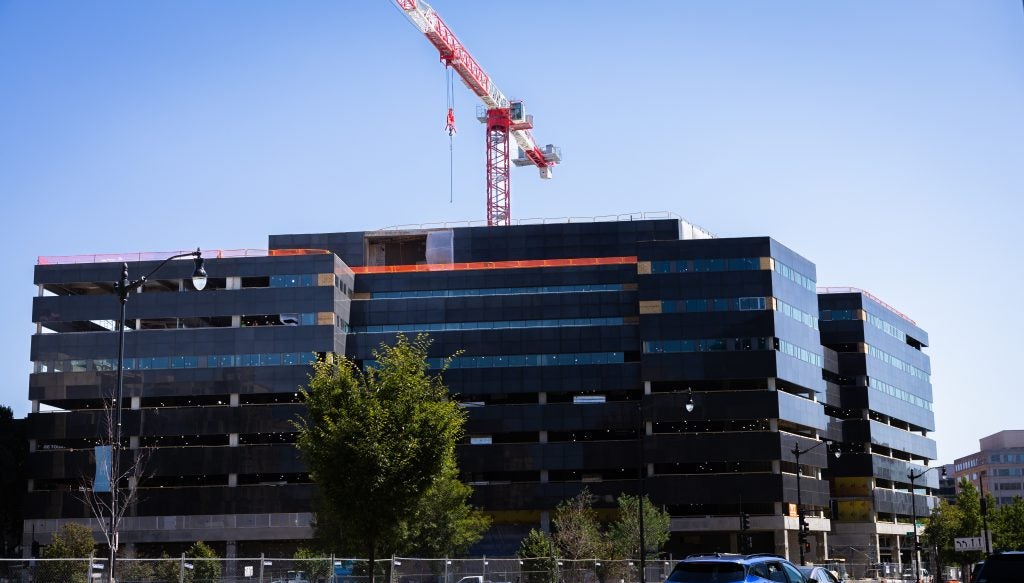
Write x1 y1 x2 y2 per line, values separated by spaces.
25 216 937 560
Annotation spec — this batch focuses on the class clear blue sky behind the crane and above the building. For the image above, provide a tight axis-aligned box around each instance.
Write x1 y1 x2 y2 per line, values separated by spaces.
0 0 1024 461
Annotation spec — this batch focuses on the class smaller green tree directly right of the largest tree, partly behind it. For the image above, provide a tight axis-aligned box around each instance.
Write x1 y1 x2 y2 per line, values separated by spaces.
397 463 490 557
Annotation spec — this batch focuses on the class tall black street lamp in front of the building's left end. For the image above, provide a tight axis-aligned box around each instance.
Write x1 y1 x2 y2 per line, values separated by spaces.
108 249 206 583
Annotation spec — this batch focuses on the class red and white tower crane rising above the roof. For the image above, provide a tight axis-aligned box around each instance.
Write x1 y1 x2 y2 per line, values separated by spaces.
394 0 562 226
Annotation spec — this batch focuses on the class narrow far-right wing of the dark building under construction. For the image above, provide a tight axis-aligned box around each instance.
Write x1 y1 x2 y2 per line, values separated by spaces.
818 288 941 576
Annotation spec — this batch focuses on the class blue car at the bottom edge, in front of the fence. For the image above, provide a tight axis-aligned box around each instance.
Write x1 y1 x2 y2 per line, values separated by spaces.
666 552 807 583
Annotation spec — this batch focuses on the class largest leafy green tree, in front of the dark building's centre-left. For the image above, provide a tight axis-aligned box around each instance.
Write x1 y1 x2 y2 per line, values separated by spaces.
296 335 465 583
